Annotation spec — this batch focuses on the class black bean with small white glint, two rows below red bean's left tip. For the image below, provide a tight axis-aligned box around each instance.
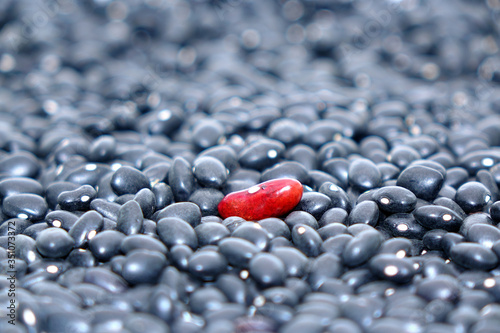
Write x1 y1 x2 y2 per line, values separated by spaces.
188 251 227 281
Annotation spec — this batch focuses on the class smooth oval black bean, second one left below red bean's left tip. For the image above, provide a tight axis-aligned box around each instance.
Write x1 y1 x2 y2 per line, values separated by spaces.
157 217 198 250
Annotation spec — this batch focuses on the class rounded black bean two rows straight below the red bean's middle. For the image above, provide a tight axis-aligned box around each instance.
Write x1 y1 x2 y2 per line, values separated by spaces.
249 253 286 287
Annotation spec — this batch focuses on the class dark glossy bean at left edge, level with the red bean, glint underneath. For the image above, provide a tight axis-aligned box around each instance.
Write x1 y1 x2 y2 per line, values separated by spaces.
2 193 48 221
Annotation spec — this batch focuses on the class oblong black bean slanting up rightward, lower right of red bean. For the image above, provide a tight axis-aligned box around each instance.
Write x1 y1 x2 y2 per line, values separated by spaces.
342 230 382 267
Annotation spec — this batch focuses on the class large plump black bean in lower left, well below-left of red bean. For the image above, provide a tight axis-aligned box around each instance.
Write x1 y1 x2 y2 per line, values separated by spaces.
121 249 167 285
